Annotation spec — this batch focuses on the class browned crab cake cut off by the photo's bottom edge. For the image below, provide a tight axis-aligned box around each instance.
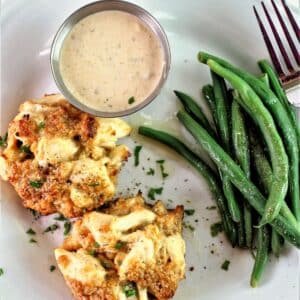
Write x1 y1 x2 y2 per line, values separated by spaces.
55 195 185 300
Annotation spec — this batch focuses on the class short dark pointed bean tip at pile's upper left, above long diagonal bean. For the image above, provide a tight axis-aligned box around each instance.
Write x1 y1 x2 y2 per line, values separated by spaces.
174 91 216 136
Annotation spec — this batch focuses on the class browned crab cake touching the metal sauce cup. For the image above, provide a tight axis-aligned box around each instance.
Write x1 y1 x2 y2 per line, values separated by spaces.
0 95 131 217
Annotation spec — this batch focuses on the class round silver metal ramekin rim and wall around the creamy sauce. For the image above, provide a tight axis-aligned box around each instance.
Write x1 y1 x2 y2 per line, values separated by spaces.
50 0 171 118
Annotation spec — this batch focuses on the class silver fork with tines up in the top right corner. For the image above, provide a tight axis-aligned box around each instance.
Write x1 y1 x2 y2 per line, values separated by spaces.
253 0 300 107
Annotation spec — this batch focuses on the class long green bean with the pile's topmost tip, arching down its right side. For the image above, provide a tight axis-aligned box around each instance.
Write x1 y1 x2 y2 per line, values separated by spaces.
198 52 300 223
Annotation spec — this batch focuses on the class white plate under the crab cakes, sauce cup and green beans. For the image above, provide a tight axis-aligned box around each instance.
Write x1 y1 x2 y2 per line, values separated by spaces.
0 0 299 300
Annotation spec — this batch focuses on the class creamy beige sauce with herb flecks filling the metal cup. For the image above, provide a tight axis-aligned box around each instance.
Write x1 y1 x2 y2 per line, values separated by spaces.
60 10 164 112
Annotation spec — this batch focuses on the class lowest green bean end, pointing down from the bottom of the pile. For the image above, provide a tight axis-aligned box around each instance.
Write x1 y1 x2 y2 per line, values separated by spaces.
250 225 270 287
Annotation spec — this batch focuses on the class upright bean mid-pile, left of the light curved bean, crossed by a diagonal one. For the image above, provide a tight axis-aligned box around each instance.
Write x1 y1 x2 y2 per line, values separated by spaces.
231 93 252 248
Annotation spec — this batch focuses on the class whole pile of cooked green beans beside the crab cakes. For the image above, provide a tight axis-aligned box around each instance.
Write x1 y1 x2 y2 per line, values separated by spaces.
139 52 300 287
